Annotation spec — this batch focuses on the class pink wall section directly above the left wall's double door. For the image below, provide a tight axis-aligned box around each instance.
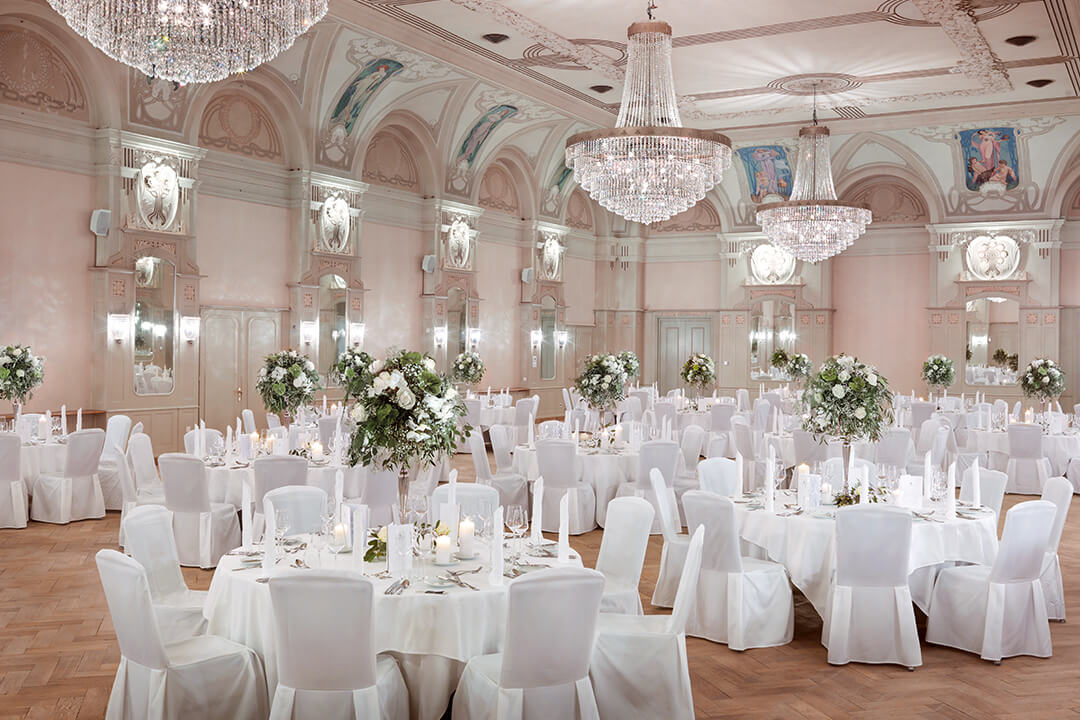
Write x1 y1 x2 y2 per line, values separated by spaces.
197 193 294 308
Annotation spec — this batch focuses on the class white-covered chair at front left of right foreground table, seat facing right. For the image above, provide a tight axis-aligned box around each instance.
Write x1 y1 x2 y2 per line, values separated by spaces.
683 490 795 650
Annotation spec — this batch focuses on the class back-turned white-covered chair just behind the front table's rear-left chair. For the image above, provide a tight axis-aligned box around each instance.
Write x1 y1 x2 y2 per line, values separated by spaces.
158 452 240 569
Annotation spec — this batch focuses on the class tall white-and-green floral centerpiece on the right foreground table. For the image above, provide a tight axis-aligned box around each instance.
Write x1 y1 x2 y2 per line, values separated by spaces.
802 355 892 492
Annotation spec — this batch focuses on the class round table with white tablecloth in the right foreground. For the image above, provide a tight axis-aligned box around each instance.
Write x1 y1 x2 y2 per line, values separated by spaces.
735 491 998 617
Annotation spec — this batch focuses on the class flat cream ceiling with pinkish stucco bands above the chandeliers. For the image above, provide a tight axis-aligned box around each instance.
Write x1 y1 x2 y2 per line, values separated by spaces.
352 0 1080 130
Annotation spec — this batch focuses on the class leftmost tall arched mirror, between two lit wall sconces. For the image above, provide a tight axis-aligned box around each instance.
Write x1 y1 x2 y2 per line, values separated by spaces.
132 256 176 395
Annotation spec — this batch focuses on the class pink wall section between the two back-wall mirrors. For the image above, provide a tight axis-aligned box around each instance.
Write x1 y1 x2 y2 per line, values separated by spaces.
832 255 930 392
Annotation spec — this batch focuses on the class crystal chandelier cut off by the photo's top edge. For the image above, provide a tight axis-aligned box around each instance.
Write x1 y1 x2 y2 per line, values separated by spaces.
49 0 327 83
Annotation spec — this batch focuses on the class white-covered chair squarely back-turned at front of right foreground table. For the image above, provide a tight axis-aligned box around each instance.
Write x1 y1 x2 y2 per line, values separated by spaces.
821 505 922 669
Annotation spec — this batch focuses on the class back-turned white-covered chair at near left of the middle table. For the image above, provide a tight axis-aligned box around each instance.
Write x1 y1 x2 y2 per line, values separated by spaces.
537 440 598 535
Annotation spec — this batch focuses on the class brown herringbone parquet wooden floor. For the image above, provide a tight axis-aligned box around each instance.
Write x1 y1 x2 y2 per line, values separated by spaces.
0 456 1080 720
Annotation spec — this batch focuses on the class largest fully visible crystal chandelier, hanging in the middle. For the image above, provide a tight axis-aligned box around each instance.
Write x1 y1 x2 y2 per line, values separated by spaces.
566 3 731 223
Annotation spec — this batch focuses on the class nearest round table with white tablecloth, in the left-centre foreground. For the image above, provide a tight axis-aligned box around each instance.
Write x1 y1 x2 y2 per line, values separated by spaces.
203 543 581 720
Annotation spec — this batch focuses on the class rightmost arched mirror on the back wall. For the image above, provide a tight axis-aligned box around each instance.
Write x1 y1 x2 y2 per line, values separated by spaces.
964 297 1020 385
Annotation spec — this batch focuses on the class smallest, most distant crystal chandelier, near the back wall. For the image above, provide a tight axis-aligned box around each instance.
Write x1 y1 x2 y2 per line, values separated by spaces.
757 125 873 262
